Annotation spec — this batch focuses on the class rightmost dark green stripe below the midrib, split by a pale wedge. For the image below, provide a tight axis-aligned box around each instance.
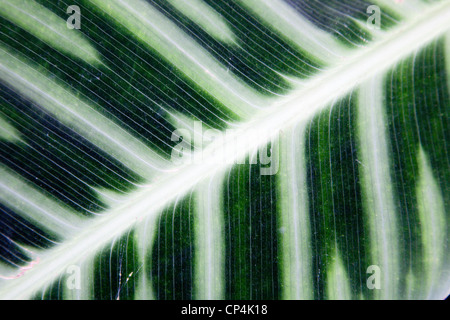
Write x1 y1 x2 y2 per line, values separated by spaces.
386 39 450 298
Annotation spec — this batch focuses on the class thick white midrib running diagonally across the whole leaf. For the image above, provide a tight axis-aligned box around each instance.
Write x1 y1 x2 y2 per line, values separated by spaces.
0 2 450 299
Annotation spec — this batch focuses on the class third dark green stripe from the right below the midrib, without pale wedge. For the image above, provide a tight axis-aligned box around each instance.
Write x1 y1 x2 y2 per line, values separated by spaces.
223 162 280 300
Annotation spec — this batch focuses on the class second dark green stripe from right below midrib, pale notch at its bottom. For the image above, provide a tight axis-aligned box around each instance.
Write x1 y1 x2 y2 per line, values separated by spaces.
305 97 369 299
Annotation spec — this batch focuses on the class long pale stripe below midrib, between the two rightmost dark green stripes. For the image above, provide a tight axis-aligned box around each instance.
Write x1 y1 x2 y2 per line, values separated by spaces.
357 76 400 299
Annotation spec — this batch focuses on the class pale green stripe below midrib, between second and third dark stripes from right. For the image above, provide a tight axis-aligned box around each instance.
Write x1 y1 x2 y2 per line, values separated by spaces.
277 124 314 300
